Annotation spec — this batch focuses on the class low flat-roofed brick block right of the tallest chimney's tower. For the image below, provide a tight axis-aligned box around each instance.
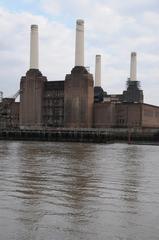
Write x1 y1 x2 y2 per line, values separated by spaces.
94 102 159 128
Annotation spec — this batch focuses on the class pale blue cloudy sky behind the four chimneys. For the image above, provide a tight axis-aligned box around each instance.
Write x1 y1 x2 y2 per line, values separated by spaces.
0 0 159 105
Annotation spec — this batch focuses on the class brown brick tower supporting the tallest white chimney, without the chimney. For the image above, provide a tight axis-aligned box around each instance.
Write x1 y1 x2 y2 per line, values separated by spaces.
64 66 94 128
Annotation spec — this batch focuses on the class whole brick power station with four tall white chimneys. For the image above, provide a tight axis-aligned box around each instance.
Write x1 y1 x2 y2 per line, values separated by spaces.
0 20 159 129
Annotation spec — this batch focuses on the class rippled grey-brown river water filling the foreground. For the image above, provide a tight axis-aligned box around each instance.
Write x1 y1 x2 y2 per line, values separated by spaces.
0 141 159 240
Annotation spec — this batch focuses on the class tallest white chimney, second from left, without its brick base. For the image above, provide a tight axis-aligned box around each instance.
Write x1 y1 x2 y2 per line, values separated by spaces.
75 19 84 66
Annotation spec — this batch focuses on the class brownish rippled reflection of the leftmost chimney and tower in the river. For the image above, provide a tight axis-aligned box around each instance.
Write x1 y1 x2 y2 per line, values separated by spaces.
12 143 45 240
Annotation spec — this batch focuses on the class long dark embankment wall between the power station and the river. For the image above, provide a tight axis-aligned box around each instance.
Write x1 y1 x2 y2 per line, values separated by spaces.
0 128 159 143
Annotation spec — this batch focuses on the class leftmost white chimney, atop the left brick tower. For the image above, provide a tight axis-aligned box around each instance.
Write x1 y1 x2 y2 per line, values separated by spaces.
30 25 39 69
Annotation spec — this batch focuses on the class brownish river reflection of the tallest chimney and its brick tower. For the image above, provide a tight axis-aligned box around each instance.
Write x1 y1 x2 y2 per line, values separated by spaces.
61 144 98 239
